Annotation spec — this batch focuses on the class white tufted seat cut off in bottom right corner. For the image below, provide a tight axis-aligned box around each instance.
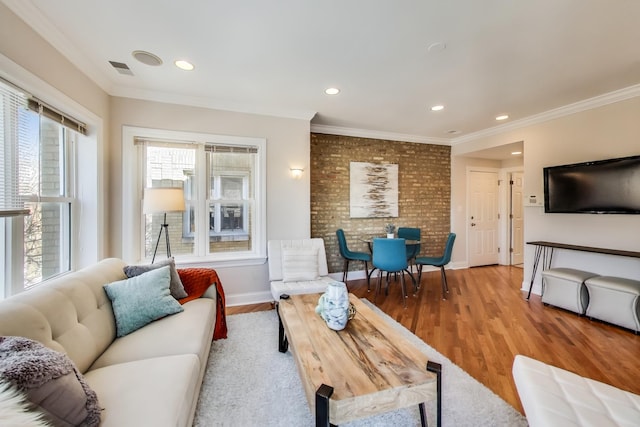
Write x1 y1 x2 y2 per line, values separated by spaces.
512 355 640 427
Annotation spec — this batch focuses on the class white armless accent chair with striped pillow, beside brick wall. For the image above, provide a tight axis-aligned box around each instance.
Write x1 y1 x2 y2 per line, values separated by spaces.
267 238 337 302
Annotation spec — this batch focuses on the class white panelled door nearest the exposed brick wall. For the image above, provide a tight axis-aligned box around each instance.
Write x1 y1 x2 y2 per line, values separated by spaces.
467 171 499 267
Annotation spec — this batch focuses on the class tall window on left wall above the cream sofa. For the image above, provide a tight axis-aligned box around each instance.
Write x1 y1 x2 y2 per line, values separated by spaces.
0 77 77 293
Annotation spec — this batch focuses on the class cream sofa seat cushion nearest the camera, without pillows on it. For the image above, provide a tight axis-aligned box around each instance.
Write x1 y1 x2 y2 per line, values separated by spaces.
85 354 201 427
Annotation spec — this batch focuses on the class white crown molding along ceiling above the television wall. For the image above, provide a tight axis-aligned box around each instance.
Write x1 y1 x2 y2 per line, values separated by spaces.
451 84 640 146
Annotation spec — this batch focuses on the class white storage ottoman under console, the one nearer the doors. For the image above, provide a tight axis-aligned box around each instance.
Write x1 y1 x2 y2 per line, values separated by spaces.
542 268 597 315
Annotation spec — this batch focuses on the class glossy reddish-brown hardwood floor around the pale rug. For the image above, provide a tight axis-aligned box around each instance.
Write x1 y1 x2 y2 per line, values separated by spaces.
227 266 640 412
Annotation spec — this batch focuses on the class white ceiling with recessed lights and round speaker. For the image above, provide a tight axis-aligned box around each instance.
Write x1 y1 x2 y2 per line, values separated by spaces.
2 0 640 159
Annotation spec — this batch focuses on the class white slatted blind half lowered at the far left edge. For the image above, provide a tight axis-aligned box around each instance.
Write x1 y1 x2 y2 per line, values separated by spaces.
0 80 29 217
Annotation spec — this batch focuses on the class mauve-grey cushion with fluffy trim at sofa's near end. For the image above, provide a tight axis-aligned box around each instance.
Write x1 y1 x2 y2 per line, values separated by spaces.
0 337 100 427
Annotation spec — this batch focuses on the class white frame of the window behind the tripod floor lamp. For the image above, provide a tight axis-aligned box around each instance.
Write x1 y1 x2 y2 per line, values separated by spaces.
122 126 267 267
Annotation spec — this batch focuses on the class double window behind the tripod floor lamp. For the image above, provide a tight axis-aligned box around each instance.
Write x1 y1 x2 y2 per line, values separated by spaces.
123 128 266 263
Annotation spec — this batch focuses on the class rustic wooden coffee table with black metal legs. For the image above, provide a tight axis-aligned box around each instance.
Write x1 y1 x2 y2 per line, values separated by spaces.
278 294 442 427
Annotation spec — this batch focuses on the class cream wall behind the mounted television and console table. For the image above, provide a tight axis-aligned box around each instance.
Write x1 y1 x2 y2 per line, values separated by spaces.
452 97 640 293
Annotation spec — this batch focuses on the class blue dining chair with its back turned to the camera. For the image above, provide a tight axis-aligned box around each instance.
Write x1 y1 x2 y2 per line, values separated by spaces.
373 238 411 308
